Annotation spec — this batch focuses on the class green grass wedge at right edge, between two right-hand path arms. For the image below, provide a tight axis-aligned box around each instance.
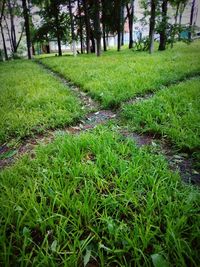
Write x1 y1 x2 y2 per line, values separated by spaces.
121 79 200 151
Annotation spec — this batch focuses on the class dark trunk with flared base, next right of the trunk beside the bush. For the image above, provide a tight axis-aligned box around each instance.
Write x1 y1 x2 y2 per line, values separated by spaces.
158 0 168 51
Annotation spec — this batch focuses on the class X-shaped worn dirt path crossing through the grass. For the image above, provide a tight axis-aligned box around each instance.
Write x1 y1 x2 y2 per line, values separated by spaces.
0 63 200 185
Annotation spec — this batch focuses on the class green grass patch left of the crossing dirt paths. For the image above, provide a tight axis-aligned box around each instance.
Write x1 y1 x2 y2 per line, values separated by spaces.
0 60 82 146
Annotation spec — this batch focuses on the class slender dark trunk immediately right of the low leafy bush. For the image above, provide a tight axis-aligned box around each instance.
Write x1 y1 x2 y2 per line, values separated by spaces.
149 0 156 54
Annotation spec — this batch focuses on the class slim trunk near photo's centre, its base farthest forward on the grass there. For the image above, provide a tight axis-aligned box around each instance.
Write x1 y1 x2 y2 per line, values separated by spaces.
94 0 101 57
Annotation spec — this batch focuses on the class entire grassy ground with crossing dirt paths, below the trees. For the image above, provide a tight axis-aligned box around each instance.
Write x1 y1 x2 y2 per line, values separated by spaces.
0 42 200 266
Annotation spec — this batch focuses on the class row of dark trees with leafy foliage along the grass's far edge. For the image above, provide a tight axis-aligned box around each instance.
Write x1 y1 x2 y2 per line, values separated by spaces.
0 0 196 60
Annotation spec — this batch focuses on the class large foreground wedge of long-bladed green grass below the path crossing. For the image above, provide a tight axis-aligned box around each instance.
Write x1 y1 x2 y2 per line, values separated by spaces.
0 128 200 267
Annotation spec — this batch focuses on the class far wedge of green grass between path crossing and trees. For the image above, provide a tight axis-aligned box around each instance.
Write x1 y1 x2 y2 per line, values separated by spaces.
42 41 200 108
